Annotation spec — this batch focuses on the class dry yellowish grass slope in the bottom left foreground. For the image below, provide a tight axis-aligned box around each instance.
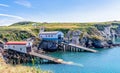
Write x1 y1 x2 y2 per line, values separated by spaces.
0 55 52 73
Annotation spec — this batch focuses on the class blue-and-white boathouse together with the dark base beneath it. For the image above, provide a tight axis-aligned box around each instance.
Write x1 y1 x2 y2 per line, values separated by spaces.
38 31 64 51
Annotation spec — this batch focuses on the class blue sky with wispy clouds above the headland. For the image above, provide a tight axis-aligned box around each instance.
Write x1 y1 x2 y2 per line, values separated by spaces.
0 0 120 26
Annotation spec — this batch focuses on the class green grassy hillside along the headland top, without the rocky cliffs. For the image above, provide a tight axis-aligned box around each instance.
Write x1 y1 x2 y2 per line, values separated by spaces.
0 22 120 41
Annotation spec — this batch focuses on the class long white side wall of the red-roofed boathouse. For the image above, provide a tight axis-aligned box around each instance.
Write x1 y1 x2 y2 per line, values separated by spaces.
4 45 27 53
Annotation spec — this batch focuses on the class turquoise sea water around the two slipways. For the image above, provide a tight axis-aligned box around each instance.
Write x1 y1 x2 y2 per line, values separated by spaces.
33 47 120 73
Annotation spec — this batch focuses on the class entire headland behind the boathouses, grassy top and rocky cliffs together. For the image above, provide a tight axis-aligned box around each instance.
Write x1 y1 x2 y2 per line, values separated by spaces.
0 22 120 48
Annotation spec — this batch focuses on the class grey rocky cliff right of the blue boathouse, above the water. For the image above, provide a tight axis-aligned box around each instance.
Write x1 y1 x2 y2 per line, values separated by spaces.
68 25 120 48
